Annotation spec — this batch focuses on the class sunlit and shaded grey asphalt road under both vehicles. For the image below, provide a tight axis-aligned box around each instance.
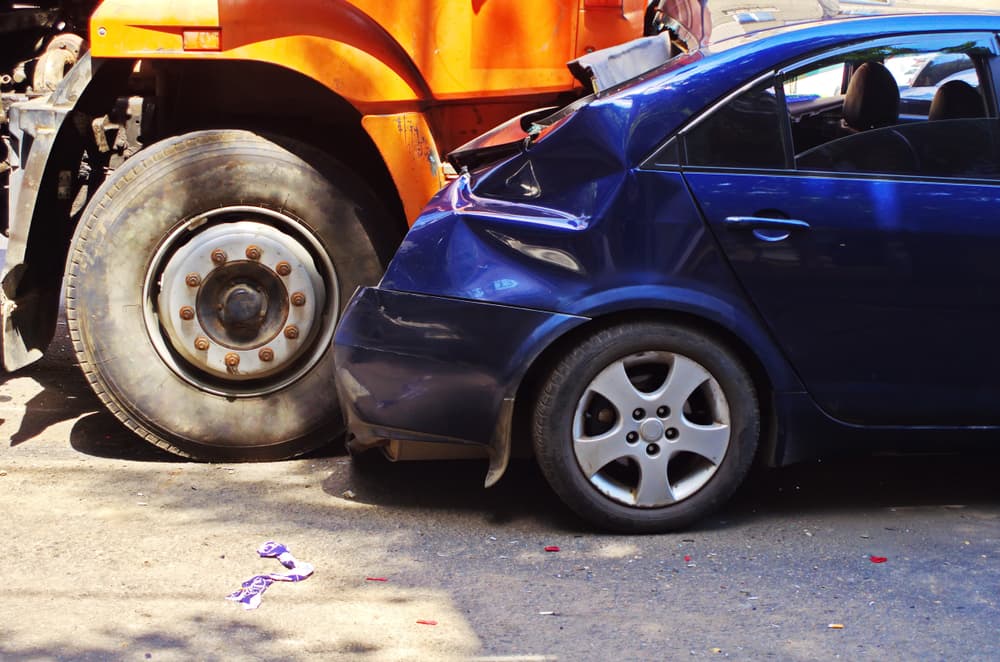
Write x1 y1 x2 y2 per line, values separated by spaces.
0 296 1000 660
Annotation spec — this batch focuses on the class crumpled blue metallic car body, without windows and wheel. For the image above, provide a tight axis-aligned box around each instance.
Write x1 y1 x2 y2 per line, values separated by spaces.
336 16 1000 474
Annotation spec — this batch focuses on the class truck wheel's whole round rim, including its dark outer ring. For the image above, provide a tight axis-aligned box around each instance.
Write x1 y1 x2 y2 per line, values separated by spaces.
144 206 339 397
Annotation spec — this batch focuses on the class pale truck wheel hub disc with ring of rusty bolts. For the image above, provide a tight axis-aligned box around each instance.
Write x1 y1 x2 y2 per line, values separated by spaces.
156 220 335 382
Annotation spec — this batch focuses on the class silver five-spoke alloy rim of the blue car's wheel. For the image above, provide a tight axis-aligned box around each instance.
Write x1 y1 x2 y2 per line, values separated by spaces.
573 352 731 508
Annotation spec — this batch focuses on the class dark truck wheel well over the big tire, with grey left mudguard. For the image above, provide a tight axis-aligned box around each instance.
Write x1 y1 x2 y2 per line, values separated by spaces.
0 56 414 371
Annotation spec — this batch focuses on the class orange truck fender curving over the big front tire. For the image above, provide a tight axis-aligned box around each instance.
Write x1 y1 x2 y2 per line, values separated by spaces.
91 0 444 222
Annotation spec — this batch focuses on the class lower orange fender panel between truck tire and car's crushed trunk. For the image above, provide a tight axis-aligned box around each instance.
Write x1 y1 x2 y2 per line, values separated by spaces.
361 113 444 223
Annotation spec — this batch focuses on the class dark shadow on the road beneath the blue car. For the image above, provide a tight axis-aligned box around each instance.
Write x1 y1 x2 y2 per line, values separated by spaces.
323 450 1000 530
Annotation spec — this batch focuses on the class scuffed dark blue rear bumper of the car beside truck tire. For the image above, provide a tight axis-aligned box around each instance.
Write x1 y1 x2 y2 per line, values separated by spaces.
334 288 585 462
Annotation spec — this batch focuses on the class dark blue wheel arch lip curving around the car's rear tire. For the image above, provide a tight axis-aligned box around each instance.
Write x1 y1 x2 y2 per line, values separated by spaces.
512 306 797 466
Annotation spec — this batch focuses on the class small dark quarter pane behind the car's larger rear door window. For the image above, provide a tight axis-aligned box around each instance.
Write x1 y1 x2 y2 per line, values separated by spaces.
682 83 786 168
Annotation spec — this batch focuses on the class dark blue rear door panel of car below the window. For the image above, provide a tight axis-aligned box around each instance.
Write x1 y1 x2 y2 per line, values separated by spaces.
687 172 1000 425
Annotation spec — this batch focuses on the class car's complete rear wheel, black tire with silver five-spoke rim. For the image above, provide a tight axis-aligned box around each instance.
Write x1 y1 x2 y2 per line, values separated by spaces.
533 322 760 533
